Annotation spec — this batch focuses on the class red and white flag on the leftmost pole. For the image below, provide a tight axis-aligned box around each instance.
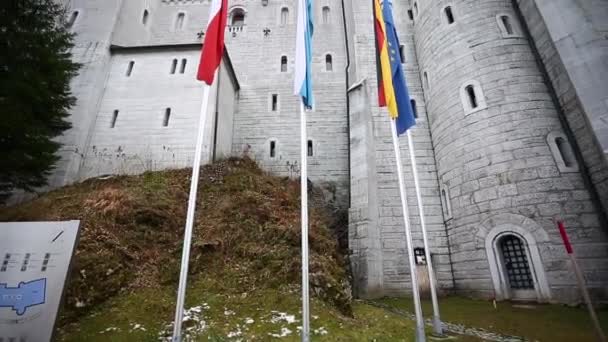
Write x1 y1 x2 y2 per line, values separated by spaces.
196 0 228 85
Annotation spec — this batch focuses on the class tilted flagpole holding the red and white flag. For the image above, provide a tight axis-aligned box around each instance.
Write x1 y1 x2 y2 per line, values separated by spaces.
172 84 210 342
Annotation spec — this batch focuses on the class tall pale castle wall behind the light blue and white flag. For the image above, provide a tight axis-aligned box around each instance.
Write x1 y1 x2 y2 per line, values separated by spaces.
226 0 348 208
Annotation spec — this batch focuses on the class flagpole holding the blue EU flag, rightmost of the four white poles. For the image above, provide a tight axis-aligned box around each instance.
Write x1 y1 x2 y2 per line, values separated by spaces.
407 130 443 336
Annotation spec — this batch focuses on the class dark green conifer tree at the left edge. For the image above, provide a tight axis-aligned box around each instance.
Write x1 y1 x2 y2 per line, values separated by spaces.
0 0 79 200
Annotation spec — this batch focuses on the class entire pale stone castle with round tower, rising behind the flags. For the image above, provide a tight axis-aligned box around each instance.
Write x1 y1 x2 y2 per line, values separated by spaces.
50 0 608 302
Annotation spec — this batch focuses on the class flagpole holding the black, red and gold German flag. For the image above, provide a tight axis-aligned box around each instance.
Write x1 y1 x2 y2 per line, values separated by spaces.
390 119 426 342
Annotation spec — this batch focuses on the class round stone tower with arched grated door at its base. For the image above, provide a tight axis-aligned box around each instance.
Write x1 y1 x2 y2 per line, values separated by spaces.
411 0 607 301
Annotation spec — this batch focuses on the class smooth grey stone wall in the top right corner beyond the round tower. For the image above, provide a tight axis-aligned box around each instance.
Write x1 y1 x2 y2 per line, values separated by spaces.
518 0 608 219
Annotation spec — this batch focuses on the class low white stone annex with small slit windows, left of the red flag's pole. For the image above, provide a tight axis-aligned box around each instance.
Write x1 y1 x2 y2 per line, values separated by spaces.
81 47 234 179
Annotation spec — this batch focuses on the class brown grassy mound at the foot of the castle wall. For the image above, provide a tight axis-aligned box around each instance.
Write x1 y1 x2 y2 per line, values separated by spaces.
0 159 352 324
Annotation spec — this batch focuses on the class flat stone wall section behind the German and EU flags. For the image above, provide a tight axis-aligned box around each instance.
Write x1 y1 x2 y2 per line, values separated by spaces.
350 1 452 295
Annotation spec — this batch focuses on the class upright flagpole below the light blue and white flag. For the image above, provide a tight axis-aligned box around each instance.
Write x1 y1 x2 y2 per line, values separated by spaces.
300 101 310 342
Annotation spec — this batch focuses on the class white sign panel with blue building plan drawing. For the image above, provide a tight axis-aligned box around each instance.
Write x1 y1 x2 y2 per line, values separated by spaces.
0 221 80 342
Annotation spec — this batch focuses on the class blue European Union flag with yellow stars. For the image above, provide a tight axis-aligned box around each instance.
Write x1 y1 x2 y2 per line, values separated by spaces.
382 0 416 135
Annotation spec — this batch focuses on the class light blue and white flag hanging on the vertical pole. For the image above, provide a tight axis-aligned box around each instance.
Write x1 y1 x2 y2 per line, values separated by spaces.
294 0 313 108
